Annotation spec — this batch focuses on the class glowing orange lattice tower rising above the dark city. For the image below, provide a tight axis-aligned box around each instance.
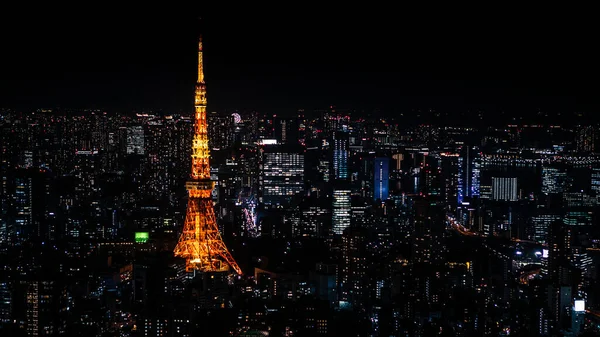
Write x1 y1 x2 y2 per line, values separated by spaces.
174 38 242 274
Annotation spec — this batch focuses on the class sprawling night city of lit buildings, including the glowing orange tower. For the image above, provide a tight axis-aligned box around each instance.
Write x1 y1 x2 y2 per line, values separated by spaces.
0 30 600 337
